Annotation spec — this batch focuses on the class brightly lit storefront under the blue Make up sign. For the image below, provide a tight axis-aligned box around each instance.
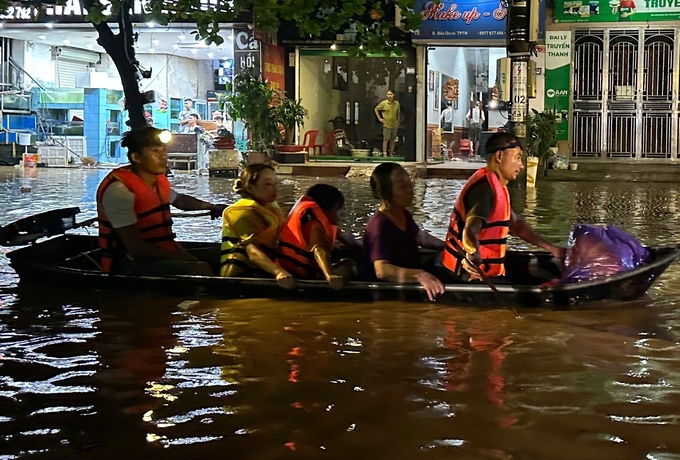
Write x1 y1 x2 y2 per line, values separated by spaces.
413 0 545 161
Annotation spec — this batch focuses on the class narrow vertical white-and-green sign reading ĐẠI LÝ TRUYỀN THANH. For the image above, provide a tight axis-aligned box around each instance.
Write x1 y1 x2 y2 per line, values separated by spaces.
545 30 571 141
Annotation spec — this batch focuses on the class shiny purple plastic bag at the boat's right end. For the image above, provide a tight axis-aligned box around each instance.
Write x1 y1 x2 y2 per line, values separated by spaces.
562 224 649 283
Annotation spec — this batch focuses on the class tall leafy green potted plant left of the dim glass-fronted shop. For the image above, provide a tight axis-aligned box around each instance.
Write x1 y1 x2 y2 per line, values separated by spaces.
221 72 280 161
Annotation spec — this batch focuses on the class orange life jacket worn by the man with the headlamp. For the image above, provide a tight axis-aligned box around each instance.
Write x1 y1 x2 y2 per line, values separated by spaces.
97 166 180 272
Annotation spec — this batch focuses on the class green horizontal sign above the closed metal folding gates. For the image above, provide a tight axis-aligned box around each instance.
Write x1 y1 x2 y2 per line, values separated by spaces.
555 0 680 22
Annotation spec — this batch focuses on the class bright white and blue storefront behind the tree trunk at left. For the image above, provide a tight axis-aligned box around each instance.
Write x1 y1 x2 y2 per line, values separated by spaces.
0 0 248 162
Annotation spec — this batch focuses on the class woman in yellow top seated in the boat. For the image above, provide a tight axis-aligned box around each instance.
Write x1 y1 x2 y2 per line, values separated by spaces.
220 164 295 289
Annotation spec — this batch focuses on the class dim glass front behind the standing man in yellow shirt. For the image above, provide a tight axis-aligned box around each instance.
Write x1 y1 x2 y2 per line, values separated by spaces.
298 50 416 161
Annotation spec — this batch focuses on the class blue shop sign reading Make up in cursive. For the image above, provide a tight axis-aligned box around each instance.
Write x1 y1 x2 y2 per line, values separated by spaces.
413 0 545 40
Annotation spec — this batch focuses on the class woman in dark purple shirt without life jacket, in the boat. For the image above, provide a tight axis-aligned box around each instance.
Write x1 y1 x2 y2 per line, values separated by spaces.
363 163 444 300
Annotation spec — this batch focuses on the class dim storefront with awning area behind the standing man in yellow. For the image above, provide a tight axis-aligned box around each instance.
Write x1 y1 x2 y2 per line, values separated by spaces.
278 18 417 161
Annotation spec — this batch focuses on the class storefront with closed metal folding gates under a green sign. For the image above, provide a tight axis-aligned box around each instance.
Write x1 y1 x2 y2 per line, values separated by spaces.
546 0 680 161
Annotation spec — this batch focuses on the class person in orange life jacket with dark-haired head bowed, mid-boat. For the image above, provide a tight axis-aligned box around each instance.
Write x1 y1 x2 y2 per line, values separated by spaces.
277 184 360 290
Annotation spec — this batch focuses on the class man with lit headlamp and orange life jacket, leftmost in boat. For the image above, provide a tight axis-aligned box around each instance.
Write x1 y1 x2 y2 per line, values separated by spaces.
97 126 226 275
